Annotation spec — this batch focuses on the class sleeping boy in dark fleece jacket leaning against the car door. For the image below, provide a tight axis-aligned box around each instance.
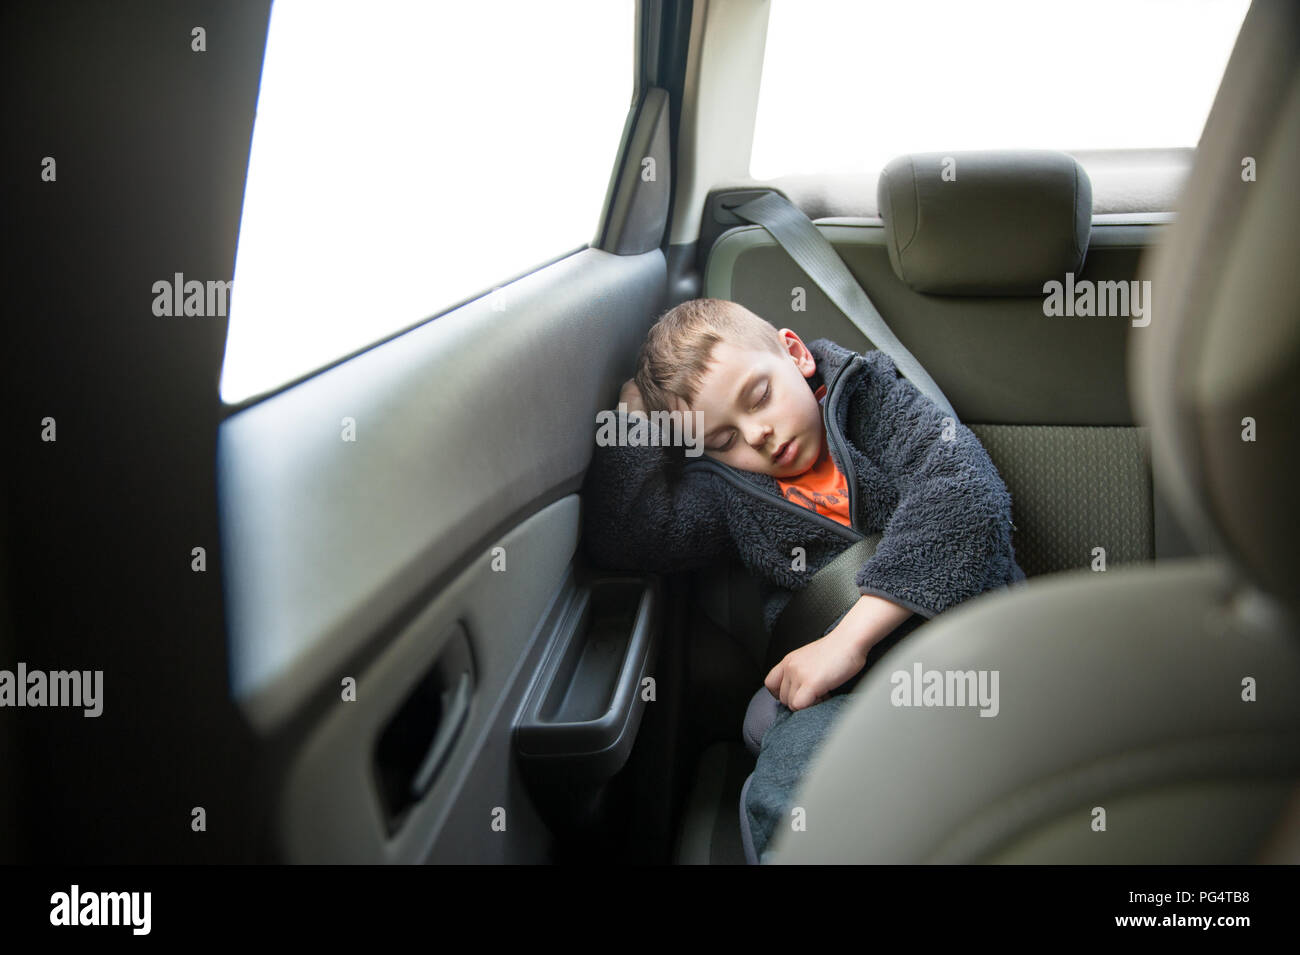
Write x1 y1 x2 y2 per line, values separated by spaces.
584 299 1024 861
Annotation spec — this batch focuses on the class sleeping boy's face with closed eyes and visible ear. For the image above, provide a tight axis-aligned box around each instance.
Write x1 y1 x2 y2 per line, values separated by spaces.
690 329 824 478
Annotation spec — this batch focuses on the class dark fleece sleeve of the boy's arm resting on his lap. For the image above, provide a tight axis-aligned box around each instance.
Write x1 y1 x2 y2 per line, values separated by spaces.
857 351 1023 617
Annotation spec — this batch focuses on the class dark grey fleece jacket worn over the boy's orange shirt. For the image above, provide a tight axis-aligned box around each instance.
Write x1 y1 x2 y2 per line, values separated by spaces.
582 338 1024 631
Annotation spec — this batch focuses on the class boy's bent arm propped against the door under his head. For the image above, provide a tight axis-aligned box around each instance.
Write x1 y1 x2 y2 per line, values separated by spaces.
582 382 735 573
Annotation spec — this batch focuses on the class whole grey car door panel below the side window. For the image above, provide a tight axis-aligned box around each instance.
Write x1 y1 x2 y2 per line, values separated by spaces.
217 248 666 861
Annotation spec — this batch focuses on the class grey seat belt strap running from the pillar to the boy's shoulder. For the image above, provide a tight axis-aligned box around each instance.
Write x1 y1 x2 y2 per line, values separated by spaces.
729 192 958 421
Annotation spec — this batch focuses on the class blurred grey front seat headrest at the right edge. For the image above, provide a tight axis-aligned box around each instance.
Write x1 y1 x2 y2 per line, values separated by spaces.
1128 3 1300 617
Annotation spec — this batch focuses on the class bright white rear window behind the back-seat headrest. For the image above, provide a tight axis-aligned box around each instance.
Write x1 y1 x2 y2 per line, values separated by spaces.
750 0 1249 179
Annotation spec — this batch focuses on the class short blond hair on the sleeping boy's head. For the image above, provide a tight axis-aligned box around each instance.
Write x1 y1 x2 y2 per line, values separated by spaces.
633 299 787 412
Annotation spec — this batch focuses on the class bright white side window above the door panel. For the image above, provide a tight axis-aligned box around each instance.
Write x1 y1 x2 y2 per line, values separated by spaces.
221 0 634 403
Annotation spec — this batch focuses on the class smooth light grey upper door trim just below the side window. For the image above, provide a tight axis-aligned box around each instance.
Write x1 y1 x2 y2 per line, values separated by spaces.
217 249 667 733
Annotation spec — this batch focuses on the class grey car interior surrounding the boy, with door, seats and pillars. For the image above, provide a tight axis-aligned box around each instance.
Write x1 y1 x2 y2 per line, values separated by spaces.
0 0 1300 865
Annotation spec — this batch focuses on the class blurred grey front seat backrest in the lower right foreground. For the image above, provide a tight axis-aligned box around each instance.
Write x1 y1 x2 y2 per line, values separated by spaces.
768 559 1300 864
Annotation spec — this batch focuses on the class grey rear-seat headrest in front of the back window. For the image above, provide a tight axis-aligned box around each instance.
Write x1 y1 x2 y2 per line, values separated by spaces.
876 149 1092 295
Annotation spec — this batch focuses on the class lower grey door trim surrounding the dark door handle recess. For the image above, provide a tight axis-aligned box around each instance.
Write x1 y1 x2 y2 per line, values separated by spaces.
276 495 581 864
